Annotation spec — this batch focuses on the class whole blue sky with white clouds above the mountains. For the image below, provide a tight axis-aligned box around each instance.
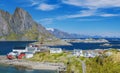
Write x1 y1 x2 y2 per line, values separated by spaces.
0 0 120 37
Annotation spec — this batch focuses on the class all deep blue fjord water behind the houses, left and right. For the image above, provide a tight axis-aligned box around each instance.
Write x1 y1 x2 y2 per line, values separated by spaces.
0 38 120 55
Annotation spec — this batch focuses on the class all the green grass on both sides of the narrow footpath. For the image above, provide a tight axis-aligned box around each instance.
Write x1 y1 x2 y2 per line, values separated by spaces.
29 50 120 73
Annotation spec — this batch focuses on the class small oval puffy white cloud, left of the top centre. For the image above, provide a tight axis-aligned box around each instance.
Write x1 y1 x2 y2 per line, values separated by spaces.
37 3 59 11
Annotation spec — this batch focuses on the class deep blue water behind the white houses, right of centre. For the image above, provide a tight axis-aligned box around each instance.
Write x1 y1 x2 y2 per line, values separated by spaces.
50 38 120 50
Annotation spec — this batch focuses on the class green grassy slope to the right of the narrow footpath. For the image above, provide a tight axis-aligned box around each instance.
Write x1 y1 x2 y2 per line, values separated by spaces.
86 50 120 73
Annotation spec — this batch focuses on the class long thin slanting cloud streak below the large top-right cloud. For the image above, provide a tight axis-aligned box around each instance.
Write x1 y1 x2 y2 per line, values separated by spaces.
40 9 120 24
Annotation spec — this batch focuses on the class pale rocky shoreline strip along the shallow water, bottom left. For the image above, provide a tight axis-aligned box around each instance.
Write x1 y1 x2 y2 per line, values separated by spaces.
0 56 64 70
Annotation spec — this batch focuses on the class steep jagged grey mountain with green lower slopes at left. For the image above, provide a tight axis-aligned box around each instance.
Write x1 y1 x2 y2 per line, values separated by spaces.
0 8 54 40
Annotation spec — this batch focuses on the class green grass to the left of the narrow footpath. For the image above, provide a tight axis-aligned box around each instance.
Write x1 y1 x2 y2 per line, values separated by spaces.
29 52 82 73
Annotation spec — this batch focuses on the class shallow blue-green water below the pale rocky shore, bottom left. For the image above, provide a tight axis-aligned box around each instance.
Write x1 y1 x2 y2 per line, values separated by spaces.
0 65 57 73
